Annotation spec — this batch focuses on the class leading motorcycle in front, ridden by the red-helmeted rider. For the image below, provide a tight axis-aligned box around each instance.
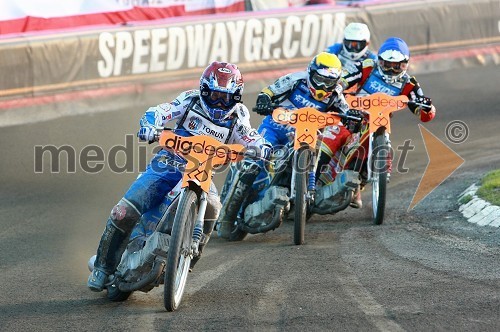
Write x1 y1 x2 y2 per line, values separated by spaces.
89 128 245 311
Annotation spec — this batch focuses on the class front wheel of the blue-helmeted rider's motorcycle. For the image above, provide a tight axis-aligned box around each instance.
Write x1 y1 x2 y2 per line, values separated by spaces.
372 130 389 225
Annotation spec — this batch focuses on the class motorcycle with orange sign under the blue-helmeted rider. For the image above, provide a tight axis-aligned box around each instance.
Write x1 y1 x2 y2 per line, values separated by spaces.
311 93 409 225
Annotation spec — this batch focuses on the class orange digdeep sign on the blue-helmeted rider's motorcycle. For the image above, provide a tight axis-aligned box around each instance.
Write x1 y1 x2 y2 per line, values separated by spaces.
346 92 408 133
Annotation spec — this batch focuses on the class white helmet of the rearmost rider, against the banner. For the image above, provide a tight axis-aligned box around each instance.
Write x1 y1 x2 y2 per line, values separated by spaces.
342 22 370 60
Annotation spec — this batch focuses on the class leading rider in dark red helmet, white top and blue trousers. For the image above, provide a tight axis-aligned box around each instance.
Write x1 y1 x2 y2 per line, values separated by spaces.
87 62 271 292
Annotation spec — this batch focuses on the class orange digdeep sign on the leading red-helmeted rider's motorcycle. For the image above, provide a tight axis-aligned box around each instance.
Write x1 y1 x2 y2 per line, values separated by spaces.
159 130 245 192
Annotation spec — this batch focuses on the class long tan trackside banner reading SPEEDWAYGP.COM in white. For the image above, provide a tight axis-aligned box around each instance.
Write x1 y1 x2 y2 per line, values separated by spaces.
0 0 500 111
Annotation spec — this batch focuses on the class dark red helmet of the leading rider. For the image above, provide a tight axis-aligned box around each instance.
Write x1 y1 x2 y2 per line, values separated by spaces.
200 61 244 121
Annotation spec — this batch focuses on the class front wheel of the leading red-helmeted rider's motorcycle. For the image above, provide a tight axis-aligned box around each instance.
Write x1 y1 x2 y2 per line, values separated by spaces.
163 189 198 311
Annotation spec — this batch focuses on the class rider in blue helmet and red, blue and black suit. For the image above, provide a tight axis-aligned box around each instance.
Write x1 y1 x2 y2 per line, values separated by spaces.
318 37 436 208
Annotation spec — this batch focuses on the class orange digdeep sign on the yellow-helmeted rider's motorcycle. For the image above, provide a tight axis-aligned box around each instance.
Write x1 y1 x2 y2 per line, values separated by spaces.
273 107 340 150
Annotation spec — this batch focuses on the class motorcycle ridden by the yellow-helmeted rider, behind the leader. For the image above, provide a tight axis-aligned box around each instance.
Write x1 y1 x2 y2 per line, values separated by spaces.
221 107 361 245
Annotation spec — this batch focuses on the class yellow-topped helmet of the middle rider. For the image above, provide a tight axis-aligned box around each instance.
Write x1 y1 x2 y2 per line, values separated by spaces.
307 52 342 101
